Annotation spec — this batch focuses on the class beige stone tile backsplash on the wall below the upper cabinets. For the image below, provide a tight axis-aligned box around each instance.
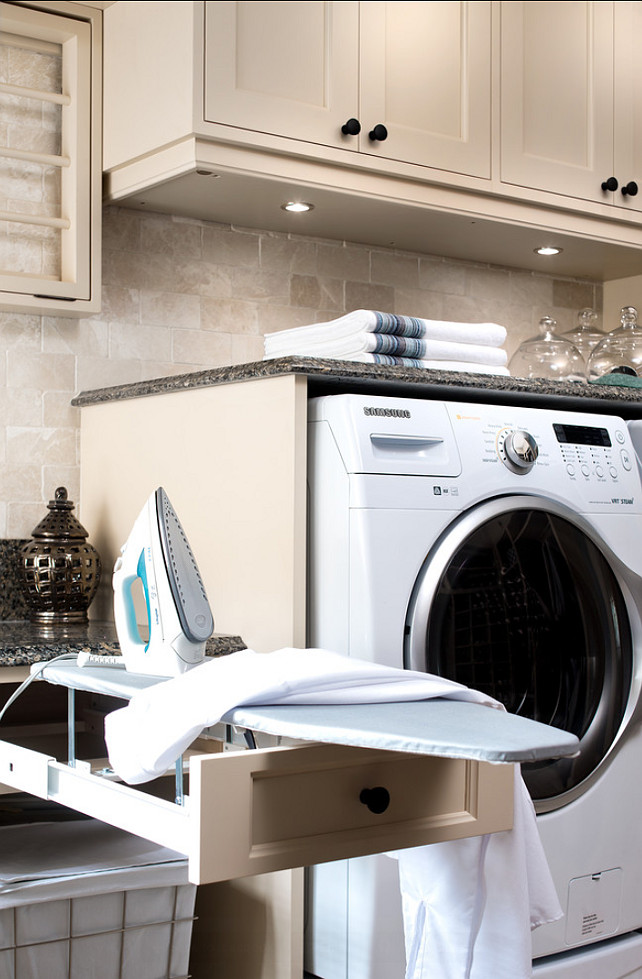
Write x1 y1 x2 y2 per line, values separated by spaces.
0 201 602 538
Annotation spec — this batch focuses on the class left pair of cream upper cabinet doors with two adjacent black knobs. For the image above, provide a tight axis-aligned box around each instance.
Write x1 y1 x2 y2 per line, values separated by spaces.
204 0 491 177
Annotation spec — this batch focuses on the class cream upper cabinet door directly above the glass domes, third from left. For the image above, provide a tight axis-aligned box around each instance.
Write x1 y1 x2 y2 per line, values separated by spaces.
501 0 619 203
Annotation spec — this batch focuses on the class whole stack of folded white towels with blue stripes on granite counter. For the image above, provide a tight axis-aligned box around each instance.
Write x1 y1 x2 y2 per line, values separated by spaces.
264 309 509 375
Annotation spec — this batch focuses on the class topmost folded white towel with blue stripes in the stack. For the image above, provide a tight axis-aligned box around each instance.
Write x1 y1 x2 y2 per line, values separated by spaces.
265 309 507 352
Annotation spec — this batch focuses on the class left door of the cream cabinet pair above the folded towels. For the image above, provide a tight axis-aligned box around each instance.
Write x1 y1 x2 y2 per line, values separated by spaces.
204 0 359 149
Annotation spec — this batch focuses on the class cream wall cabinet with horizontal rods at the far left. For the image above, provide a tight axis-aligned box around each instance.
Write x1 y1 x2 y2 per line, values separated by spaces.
0 2 102 316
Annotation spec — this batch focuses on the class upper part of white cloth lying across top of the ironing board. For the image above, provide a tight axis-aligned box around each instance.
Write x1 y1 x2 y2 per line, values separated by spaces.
105 649 502 785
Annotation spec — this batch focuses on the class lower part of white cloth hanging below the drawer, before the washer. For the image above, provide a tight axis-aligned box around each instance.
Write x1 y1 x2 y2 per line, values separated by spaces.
390 766 563 979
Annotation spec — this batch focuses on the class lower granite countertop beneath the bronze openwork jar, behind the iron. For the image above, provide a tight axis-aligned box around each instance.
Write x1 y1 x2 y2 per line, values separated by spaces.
0 619 245 666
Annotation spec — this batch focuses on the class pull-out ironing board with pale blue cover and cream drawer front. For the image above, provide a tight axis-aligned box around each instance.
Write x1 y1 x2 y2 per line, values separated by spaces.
0 663 577 883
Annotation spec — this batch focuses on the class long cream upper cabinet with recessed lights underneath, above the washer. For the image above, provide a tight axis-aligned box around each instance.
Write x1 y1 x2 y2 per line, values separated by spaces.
103 0 642 279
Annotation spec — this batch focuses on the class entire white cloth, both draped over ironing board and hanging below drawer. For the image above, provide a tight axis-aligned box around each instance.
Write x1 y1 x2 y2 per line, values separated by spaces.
105 649 561 979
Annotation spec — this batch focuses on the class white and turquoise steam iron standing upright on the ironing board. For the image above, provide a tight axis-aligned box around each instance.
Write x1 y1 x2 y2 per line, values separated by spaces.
112 486 214 677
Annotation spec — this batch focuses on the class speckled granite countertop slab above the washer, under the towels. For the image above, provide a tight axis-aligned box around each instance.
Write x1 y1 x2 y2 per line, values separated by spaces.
72 357 642 412
